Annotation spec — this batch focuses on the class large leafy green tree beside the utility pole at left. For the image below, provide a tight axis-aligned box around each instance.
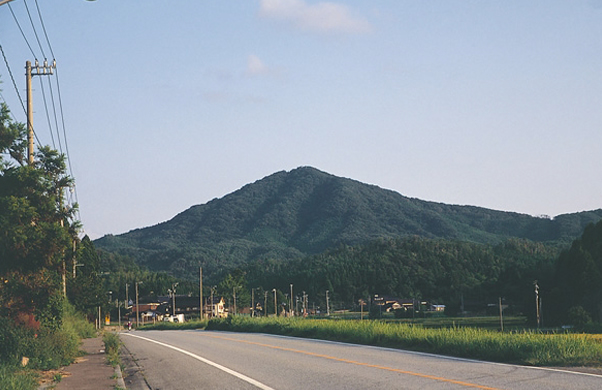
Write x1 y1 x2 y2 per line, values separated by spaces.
0 104 78 326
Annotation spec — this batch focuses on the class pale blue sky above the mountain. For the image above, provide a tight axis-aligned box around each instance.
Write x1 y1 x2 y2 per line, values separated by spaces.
0 0 602 239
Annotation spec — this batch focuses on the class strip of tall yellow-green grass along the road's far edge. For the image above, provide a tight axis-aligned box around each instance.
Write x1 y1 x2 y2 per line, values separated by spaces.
206 317 602 366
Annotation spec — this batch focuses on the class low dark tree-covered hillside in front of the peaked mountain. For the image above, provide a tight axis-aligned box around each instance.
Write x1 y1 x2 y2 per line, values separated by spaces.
246 237 559 314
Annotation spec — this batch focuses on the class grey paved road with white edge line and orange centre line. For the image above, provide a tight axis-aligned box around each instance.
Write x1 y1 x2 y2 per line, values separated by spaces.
121 331 602 390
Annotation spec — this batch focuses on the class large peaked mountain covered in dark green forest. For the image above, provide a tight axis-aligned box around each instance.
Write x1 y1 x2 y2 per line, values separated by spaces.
95 167 602 276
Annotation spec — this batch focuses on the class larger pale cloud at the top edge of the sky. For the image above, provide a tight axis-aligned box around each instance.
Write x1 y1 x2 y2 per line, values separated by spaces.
259 0 370 33
